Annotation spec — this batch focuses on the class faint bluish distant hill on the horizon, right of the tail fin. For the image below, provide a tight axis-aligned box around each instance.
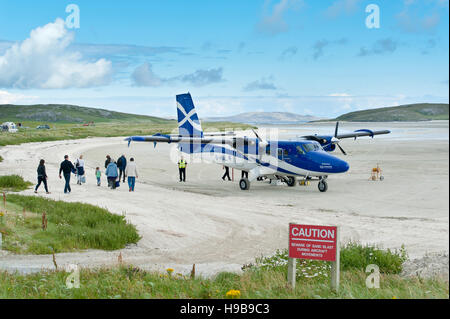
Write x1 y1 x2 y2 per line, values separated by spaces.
204 112 319 124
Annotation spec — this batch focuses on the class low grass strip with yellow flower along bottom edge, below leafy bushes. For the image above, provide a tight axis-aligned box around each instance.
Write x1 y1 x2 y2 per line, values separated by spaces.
0 265 448 299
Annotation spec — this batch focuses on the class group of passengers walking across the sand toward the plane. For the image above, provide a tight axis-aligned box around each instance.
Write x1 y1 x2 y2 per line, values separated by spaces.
34 155 138 194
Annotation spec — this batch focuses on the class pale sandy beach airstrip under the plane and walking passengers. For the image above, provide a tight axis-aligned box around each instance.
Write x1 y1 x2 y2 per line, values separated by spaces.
0 121 449 275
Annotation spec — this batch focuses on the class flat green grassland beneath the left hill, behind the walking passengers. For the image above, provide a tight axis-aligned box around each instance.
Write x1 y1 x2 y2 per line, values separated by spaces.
0 120 251 146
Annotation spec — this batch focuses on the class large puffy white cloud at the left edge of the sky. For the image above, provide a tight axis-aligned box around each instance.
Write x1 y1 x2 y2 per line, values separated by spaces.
0 18 112 89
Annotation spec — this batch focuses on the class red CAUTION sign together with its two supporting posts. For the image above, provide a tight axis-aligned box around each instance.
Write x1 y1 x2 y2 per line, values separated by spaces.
288 223 340 291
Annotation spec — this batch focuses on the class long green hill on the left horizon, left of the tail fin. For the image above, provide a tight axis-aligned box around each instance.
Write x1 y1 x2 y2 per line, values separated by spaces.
0 104 174 123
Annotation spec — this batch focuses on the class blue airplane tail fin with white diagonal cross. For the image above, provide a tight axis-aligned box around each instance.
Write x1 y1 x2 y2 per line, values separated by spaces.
177 93 203 137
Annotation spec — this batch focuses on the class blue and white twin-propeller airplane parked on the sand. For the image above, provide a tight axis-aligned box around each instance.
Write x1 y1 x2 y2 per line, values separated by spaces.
125 93 390 192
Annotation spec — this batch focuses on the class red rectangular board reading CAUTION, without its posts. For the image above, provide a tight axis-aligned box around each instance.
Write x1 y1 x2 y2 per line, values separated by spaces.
289 224 337 261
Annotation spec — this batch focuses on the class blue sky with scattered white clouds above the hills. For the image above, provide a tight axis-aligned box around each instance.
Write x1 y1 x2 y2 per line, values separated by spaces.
0 0 449 118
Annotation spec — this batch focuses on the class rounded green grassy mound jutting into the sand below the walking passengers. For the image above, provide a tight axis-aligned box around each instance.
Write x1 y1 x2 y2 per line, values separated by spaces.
0 194 140 254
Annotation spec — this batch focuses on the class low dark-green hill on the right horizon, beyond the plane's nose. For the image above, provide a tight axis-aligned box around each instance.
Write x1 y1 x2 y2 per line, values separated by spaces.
333 103 448 122
